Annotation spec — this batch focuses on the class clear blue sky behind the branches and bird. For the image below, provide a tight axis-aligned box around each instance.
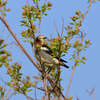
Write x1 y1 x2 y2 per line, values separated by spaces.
0 0 100 100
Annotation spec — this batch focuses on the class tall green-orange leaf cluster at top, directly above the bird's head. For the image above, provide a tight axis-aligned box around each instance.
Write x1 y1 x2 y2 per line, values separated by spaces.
21 0 53 44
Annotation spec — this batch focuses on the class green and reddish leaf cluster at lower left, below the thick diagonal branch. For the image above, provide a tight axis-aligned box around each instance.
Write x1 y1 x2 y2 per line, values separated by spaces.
7 62 37 95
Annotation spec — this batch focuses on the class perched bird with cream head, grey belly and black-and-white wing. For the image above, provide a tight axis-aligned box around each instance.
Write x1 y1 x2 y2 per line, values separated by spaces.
35 35 69 69
